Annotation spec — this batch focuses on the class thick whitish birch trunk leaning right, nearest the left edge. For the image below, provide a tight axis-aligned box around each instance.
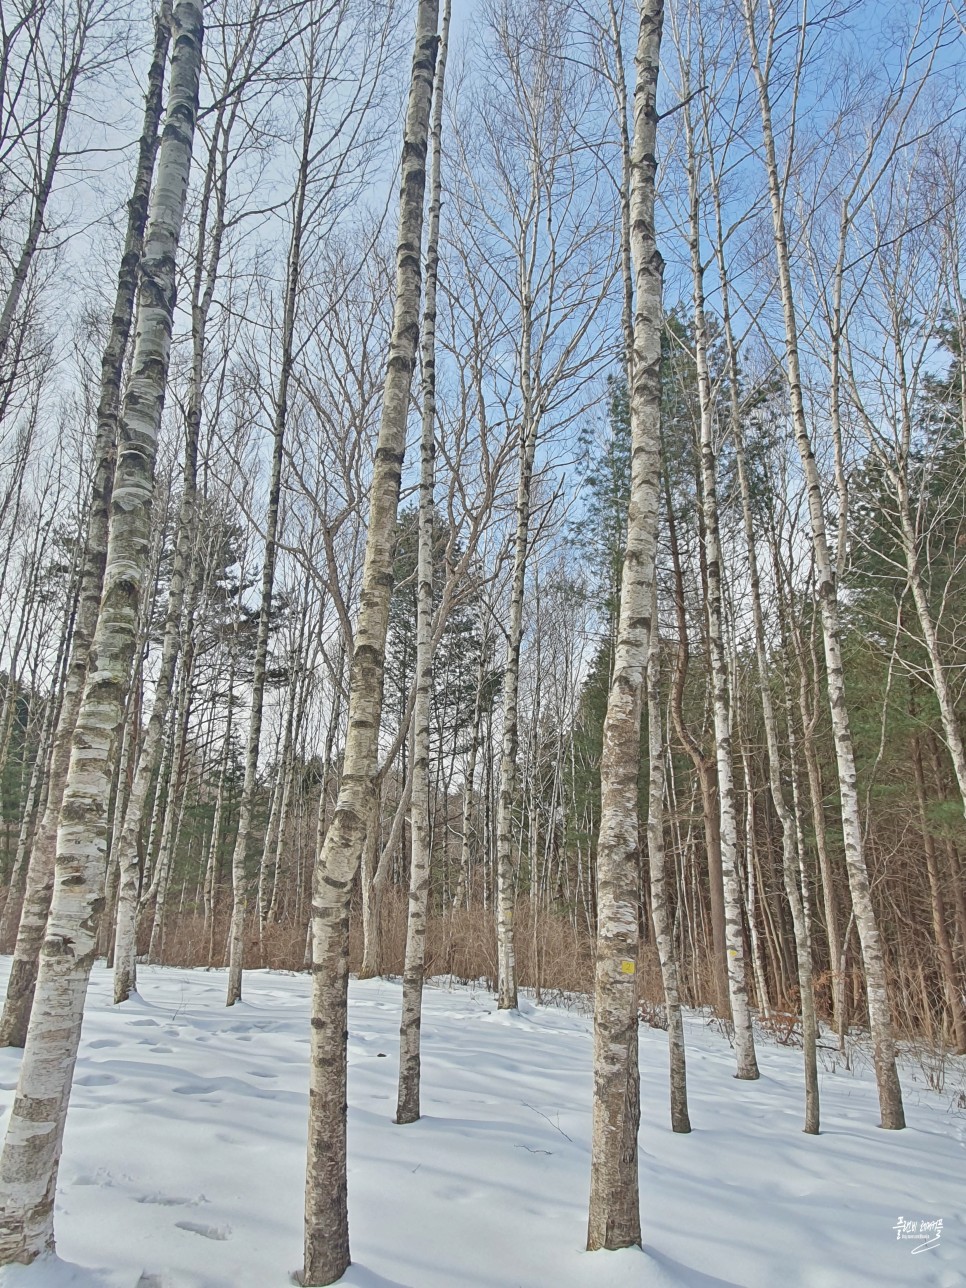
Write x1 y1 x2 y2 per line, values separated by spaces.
0 0 202 1265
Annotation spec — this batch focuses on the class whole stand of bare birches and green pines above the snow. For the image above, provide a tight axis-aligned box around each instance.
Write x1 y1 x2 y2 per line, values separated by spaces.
0 0 966 1284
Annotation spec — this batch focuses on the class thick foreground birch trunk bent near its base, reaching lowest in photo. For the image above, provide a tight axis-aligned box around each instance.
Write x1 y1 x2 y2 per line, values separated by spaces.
303 0 439 1288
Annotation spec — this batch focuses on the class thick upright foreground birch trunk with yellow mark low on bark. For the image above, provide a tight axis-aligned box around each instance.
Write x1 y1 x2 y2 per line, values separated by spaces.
587 0 663 1251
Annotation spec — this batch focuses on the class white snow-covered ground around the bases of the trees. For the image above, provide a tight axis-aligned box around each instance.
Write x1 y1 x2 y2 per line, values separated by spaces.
0 961 966 1288
